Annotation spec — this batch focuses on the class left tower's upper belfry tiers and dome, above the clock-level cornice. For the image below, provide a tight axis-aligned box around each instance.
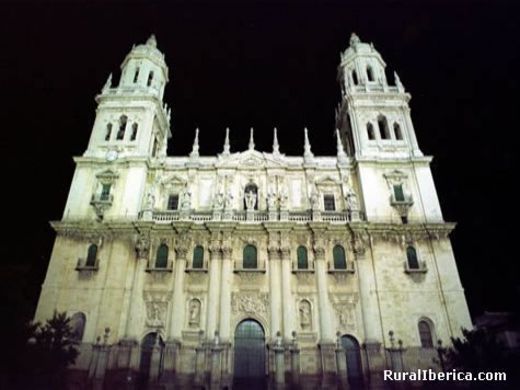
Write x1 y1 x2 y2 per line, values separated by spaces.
84 35 171 161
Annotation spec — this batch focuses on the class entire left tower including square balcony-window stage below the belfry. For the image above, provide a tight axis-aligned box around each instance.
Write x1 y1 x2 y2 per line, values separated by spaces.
64 35 171 221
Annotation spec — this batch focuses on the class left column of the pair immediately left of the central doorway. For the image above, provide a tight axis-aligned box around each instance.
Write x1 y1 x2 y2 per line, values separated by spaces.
206 240 221 337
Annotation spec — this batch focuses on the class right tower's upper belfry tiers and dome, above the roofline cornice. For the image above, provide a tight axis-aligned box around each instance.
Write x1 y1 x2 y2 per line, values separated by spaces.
336 33 422 159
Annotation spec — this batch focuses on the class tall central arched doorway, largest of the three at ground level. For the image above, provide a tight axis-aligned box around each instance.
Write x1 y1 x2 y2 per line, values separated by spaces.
233 320 266 389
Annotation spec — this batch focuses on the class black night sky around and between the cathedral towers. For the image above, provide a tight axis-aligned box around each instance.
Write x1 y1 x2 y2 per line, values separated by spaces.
0 0 520 315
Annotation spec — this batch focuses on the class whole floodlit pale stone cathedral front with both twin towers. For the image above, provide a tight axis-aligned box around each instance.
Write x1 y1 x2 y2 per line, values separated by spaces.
35 34 471 389
